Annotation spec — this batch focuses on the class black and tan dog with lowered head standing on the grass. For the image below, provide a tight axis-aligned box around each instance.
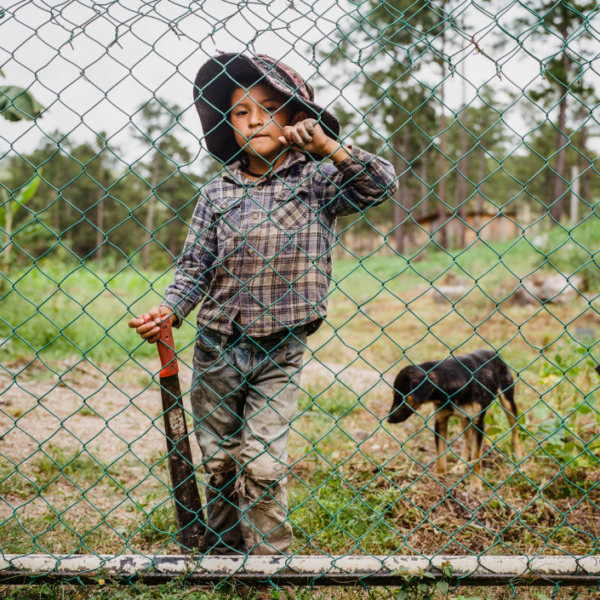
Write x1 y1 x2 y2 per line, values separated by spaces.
388 350 523 487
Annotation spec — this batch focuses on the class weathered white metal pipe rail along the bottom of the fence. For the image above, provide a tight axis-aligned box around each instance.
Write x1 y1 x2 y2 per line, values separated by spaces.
2 555 598 587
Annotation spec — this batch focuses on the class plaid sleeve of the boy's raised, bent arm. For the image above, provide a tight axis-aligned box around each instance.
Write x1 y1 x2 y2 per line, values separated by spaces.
315 146 398 218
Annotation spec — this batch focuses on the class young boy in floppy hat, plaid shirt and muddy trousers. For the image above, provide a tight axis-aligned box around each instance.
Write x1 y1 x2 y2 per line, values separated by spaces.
129 54 397 554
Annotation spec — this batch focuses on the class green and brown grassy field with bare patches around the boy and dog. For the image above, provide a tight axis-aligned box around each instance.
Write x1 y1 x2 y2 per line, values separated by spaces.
0 233 600 598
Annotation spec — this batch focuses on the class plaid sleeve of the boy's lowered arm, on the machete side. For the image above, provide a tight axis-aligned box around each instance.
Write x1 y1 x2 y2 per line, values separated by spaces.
161 190 218 327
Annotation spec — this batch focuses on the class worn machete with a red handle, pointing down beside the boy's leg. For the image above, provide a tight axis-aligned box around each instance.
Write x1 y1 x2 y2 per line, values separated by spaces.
144 315 206 552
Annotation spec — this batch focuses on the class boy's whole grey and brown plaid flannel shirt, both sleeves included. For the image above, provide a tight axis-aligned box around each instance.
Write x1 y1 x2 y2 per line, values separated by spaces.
163 147 398 337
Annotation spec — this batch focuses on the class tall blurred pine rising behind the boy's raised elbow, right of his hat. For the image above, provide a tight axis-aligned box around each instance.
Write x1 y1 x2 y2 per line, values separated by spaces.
327 0 444 254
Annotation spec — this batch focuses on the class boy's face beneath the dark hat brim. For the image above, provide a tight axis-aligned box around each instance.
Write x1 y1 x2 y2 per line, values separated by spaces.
231 83 290 162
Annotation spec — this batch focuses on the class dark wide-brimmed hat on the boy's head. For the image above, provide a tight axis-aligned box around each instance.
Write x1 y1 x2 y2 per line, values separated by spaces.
194 53 340 165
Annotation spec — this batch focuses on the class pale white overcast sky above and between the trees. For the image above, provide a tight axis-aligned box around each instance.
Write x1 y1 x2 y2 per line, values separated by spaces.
0 0 600 175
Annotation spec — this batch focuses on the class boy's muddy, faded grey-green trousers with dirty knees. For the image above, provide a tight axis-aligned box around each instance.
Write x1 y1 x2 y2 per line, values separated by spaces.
191 329 306 554
